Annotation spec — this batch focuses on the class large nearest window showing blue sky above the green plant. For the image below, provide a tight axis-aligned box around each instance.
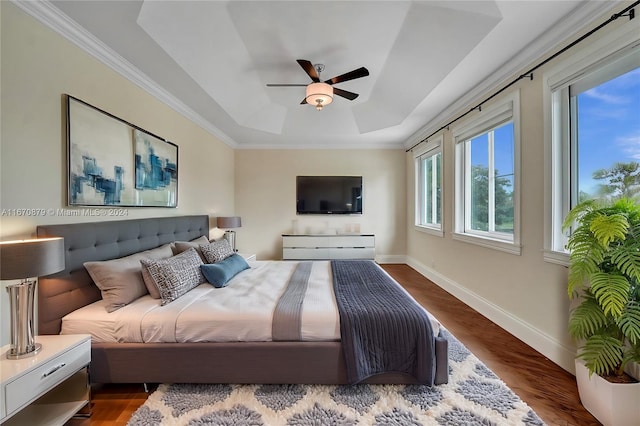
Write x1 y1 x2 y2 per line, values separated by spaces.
545 28 640 264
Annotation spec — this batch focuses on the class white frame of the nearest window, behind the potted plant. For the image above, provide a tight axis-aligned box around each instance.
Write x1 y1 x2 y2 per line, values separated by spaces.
543 22 640 266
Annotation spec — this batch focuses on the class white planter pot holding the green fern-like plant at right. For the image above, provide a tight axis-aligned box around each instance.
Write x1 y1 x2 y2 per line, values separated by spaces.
576 359 640 426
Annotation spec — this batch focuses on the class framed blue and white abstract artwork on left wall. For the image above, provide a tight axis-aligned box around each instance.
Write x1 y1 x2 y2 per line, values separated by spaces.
66 95 178 207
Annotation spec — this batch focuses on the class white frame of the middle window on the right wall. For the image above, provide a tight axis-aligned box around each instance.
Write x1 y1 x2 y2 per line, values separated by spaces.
452 90 521 255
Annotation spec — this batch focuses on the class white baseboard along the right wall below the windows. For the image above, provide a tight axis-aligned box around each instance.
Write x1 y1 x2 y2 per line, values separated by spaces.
405 257 576 374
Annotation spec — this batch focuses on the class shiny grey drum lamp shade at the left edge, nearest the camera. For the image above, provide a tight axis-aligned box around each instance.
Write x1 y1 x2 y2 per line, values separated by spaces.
0 238 64 280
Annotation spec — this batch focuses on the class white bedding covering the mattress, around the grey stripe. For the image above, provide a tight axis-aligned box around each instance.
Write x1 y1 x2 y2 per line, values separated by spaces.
61 261 440 343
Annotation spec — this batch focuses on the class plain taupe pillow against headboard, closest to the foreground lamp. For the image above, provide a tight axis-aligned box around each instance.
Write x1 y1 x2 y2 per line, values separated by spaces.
84 244 173 312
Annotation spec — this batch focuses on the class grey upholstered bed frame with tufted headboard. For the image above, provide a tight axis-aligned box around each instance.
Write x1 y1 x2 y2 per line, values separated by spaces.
37 216 448 384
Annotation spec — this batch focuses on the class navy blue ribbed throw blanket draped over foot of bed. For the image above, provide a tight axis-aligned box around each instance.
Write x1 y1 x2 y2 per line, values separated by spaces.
331 260 436 386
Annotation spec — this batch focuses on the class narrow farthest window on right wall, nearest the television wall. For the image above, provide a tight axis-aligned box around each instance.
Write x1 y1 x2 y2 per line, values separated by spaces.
415 136 442 236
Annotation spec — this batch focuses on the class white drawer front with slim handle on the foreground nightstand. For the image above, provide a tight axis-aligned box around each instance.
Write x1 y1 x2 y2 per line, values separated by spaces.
5 340 91 415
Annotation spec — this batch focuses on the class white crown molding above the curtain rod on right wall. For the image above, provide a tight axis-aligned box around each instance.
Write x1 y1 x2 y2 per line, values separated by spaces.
404 1 621 149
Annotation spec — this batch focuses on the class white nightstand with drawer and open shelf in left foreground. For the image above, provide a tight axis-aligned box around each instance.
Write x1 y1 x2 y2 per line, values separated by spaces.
0 334 91 426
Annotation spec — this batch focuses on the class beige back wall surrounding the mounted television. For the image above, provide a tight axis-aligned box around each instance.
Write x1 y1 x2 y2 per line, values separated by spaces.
235 150 406 261
